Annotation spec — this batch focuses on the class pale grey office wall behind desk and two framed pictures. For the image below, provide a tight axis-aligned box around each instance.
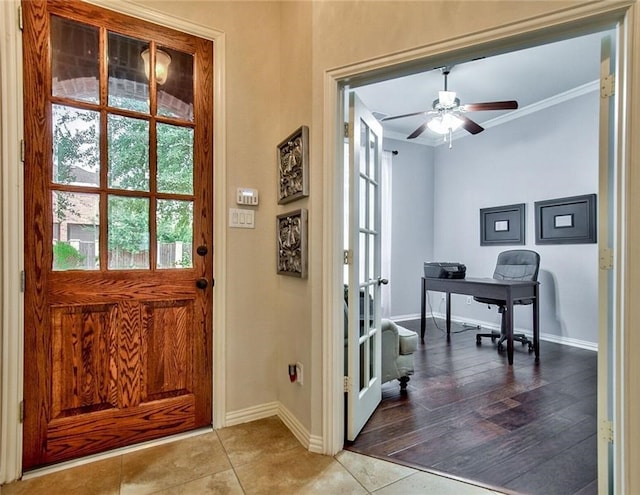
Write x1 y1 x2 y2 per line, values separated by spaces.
431 91 599 344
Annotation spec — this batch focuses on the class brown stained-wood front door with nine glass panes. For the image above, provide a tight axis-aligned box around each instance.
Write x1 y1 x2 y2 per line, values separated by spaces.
22 0 213 469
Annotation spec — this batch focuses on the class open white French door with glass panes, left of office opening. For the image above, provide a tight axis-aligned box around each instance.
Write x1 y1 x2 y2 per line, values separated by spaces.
345 92 386 440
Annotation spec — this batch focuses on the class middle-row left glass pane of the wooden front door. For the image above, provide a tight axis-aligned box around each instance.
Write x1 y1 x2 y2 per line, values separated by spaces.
52 105 100 186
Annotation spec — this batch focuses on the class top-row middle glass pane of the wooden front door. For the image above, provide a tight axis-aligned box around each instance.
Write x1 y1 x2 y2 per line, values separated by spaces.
107 33 149 113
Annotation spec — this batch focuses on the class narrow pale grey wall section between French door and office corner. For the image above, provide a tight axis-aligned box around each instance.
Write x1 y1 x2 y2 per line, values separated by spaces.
383 139 434 318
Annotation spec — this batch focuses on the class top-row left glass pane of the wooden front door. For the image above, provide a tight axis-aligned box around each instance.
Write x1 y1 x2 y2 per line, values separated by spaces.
51 15 100 103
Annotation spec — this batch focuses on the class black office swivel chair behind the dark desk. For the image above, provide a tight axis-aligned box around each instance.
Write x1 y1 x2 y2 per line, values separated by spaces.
473 249 540 352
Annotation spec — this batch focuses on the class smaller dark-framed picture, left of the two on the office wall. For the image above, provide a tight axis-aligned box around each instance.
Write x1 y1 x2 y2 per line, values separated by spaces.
480 203 525 246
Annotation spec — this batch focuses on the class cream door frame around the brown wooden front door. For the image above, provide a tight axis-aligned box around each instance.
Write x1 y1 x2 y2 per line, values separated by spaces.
0 0 226 484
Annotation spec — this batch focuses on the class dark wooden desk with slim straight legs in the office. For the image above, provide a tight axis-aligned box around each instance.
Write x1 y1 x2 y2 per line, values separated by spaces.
420 277 540 365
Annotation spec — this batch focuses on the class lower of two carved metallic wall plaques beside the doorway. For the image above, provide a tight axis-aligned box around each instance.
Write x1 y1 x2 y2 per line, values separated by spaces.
276 208 307 278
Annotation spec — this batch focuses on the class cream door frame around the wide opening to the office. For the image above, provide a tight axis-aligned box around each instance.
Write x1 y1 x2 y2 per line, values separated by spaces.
322 4 640 493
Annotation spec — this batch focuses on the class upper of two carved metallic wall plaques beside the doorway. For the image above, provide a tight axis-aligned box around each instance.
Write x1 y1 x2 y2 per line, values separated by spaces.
277 125 309 204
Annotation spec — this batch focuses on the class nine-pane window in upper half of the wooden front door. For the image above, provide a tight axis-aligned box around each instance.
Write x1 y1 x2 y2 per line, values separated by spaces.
50 15 194 270
